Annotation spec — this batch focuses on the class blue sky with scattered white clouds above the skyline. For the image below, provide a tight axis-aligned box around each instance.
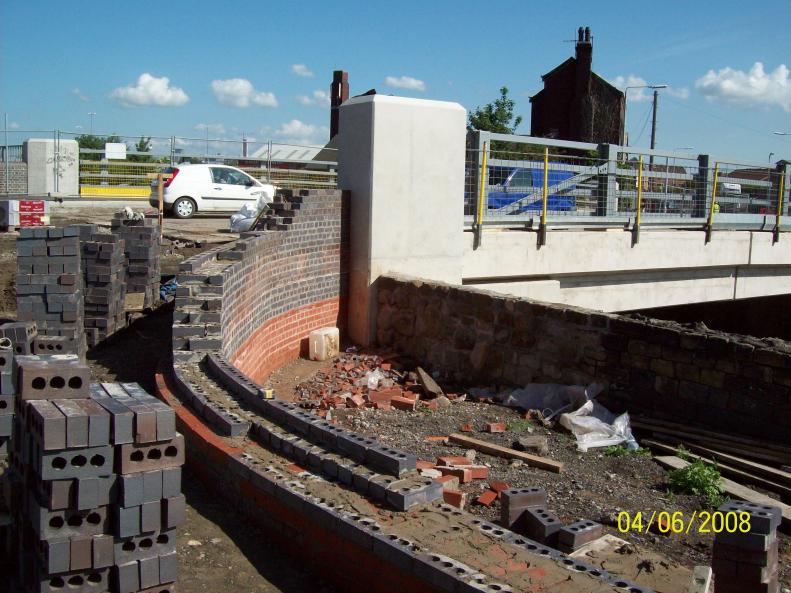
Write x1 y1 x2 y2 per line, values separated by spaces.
0 0 791 162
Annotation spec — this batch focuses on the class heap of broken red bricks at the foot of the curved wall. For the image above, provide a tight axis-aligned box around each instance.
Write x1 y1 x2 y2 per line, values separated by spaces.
296 353 464 415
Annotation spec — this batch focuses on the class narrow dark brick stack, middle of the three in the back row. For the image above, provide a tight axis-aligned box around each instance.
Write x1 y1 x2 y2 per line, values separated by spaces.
82 233 126 348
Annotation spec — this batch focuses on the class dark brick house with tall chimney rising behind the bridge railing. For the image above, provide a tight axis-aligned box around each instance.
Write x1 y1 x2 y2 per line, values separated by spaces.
530 27 625 144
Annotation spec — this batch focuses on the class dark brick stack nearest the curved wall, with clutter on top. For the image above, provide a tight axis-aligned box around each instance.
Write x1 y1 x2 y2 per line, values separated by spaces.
111 212 160 307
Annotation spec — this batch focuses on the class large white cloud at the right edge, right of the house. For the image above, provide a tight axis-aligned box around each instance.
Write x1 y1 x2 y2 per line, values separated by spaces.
695 62 791 112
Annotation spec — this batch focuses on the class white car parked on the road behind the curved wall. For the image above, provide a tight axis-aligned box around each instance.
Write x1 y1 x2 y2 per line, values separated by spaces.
149 164 276 218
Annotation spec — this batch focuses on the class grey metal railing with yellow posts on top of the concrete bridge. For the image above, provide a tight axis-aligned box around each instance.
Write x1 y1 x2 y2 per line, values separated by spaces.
464 132 791 244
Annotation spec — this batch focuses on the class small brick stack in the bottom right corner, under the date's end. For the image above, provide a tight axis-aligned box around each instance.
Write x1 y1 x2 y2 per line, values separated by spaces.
711 501 782 593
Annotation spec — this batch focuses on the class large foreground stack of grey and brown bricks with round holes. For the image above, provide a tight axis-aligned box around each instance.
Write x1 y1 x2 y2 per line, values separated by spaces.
5 355 185 593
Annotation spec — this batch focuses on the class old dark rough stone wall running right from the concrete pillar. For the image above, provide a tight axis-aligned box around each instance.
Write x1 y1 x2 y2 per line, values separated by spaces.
377 276 791 442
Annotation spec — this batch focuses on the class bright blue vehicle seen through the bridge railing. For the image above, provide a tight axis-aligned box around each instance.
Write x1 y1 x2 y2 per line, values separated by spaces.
487 166 576 214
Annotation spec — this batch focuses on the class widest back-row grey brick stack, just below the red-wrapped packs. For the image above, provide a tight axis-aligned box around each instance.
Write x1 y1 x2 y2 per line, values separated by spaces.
16 227 86 357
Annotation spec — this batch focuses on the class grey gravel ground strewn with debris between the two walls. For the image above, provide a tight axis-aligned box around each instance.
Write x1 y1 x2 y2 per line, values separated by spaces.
290 354 791 587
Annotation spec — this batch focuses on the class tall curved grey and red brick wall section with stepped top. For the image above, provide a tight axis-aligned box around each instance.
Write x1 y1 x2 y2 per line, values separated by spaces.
173 190 348 383
